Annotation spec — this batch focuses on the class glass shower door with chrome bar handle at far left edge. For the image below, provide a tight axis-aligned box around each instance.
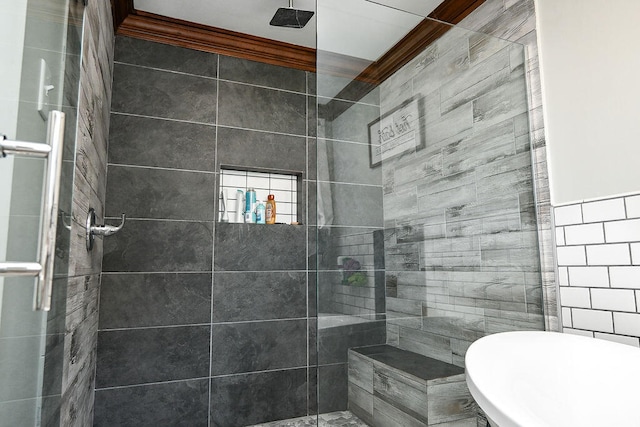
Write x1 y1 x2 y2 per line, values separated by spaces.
0 0 84 427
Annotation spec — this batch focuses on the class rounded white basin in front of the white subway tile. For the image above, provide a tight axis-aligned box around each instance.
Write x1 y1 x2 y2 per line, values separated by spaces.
465 331 640 427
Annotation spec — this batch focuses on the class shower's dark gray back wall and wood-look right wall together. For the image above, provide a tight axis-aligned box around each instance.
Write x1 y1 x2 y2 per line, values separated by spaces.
94 0 554 426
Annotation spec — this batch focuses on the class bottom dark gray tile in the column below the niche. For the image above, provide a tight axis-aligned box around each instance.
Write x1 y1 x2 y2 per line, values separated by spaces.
211 368 307 427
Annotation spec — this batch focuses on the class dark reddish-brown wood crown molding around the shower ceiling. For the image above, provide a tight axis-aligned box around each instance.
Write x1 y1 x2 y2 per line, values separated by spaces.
111 0 485 91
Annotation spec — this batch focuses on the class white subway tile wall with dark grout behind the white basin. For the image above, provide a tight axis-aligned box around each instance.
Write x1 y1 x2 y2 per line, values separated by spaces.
554 195 640 347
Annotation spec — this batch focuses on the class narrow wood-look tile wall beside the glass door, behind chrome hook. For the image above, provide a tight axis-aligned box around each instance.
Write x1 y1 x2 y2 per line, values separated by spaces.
60 1 114 426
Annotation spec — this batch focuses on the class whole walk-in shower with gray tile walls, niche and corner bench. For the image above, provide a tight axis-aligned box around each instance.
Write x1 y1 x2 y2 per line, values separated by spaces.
0 0 556 427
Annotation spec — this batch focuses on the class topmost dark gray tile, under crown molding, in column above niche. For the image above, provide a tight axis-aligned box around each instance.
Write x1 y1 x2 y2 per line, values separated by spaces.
220 56 307 93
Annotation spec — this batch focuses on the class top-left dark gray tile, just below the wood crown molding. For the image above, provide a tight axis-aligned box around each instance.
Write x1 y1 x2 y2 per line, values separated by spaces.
115 36 218 77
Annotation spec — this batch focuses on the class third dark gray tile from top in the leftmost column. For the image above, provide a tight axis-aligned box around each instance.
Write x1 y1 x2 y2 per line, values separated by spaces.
109 114 216 171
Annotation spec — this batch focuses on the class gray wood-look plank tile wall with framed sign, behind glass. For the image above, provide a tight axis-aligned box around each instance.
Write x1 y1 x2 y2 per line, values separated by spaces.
380 0 557 365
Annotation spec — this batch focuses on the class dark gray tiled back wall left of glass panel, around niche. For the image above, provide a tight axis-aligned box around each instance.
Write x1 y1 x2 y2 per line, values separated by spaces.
94 37 315 427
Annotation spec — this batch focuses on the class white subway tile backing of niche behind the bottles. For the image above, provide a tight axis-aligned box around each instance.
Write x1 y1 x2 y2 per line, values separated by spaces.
219 169 298 224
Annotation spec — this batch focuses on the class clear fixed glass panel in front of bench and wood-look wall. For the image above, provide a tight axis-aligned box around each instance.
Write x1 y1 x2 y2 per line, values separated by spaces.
317 0 545 425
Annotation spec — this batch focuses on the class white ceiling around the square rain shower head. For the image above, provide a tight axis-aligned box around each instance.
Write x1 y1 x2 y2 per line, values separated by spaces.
134 0 442 61
